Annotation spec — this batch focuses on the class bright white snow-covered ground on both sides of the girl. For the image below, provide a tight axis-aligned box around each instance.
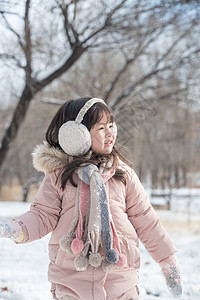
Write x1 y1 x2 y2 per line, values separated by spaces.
0 191 200 300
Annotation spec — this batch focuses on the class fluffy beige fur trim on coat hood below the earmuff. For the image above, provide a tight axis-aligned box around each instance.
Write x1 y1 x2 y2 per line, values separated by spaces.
32 141 71 173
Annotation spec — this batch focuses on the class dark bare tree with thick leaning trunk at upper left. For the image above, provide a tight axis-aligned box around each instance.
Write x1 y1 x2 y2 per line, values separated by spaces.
0 0 134 165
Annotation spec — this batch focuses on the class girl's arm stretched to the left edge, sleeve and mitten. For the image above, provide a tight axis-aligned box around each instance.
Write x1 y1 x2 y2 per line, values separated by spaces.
0 173 61 243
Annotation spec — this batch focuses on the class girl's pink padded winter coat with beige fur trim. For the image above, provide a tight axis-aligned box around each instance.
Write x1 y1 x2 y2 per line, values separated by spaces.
19 144 176 300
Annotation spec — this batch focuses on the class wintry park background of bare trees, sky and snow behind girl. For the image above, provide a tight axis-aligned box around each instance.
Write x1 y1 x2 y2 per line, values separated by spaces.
0 0 200 300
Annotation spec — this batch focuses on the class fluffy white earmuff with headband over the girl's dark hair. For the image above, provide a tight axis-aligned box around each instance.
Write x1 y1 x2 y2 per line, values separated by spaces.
58 98 106 156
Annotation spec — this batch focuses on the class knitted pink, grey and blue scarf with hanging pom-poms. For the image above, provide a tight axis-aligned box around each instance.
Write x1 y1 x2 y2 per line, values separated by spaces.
60 164 126 272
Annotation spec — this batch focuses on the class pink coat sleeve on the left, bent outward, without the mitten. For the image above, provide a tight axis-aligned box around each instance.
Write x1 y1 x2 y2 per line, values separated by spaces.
17 173 61 243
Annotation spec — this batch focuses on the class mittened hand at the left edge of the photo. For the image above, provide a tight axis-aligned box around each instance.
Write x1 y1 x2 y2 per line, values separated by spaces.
0 217 23 242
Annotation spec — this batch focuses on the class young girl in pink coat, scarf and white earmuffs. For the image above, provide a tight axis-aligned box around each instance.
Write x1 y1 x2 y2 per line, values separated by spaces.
0 98 182 300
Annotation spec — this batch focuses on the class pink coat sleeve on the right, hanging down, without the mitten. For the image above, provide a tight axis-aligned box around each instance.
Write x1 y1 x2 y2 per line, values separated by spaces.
126 169 176 263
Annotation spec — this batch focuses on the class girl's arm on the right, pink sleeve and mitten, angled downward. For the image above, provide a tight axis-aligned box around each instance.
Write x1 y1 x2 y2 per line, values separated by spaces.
126 171 182 297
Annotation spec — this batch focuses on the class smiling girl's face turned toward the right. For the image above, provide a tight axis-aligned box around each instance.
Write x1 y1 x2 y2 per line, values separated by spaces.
90 112 116 154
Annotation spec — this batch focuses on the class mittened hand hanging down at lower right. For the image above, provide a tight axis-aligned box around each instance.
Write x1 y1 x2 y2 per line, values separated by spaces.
160 255 182 298
